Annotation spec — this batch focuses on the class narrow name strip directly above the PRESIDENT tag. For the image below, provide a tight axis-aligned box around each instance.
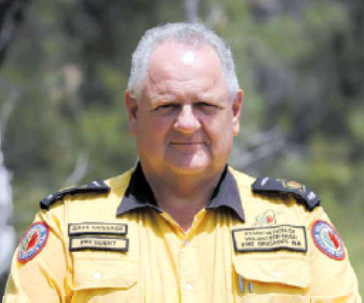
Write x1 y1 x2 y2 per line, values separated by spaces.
68 222 128 236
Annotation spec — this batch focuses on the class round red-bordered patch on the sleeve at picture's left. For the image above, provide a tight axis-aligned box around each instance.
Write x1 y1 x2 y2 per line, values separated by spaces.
18 222 49 263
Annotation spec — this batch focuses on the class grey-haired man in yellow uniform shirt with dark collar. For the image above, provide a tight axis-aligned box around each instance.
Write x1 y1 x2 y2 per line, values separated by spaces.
5 23 361 303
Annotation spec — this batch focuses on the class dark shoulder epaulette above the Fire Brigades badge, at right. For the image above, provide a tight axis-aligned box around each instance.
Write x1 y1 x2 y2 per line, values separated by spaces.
252 177 320 211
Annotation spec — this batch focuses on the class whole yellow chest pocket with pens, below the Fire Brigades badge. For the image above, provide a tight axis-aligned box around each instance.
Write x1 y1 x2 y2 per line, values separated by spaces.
234 252 311 303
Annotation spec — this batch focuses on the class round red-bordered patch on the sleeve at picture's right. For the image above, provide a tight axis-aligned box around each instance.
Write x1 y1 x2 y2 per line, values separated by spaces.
311 220 345 260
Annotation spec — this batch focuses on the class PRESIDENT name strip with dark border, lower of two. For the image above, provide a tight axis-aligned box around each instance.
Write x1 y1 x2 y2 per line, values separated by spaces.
70 236 129 252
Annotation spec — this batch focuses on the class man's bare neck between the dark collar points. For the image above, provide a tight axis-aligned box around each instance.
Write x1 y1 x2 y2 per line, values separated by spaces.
145 172 222 231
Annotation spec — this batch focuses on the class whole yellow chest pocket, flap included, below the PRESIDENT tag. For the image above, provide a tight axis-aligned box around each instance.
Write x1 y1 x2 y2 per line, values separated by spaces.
70 257 139 303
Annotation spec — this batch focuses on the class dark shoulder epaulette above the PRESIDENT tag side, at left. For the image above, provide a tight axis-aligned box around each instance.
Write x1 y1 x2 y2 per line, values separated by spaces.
39 181 110 210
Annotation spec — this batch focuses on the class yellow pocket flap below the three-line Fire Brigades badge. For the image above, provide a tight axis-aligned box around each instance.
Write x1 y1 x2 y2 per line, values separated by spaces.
234 255 311 288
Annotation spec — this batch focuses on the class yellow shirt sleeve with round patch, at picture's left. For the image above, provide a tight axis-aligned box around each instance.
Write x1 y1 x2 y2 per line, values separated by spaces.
3 205 69 303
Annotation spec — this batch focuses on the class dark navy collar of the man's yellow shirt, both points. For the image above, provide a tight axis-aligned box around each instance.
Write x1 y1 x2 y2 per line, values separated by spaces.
116 163 245 221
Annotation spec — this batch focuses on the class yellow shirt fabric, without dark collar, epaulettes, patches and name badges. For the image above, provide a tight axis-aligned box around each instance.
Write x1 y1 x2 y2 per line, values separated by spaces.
3 169 361 303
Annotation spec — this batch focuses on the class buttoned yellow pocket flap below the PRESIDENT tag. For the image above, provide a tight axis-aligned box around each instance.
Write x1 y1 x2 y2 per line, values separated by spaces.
73 259 138 290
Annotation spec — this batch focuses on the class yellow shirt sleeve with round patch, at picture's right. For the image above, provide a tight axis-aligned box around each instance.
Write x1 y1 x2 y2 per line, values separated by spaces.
307 206 361 303
